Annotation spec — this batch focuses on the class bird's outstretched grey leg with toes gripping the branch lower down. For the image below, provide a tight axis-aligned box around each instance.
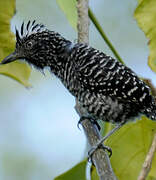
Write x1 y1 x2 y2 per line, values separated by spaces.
88 122 125 161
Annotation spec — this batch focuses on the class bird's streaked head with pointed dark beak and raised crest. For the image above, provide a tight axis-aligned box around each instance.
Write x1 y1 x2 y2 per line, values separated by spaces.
1 21 71 69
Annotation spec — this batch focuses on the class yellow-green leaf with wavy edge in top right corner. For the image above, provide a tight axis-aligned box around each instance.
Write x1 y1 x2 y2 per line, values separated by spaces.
134 0 156 72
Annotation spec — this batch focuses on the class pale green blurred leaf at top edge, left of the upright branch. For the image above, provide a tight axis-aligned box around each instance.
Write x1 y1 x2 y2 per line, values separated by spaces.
56 0 77 30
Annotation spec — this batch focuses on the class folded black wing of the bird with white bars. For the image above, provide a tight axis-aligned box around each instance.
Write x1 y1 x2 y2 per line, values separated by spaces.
75 49 150 105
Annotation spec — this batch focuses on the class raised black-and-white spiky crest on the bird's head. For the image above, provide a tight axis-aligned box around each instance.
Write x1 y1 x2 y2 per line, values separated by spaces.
15 20 46 43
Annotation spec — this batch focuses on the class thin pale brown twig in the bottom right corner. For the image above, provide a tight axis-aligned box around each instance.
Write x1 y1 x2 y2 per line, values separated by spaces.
138 134 156 180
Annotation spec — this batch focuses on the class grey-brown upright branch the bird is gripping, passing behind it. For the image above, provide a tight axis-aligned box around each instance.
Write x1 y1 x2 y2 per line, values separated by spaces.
75 0 116 180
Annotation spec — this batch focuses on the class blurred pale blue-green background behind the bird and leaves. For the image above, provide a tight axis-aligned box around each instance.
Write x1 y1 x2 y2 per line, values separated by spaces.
0 0 156 180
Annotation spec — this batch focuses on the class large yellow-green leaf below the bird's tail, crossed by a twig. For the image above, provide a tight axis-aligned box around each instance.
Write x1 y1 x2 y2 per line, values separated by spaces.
105 117 156 180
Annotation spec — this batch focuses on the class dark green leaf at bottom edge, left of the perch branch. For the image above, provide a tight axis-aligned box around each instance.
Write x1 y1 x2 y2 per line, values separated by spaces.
54 160 87 180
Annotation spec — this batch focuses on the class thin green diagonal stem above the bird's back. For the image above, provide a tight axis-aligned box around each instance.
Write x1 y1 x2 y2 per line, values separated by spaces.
88 8 124 64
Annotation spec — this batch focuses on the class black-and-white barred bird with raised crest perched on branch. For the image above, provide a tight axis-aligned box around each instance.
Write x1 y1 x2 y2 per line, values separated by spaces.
1 21 156 154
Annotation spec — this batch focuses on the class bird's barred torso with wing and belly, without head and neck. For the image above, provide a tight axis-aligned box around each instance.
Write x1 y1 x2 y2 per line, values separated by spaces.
65 44 156 122
